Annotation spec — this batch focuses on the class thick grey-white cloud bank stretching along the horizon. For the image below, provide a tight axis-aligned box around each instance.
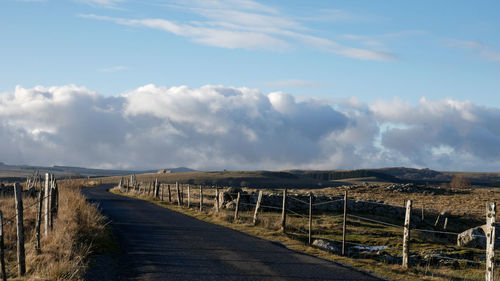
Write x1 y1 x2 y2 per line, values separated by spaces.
0 84 500 170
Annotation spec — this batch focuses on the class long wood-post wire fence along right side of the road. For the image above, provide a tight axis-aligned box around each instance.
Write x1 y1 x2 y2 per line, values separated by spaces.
118 176 498 280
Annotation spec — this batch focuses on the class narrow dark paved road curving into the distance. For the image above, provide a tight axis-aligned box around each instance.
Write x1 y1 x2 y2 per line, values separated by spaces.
83 185 380 281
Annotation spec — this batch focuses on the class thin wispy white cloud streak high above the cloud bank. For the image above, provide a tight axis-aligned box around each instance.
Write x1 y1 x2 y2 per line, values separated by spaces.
80 0 395 61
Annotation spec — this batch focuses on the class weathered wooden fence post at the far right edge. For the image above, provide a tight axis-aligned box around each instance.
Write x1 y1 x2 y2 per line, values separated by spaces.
486 202 497 281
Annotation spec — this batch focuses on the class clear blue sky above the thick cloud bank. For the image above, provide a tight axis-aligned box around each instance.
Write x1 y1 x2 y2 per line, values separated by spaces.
0 0 500 106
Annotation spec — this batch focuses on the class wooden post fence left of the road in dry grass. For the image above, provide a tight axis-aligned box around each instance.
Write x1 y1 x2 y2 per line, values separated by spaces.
0 173 59 280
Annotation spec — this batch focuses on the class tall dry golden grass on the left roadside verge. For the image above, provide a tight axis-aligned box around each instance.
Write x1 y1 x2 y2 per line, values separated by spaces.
0 181 110 280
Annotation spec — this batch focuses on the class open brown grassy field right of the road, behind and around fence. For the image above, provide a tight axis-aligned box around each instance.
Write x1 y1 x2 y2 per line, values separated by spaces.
109 174 500 280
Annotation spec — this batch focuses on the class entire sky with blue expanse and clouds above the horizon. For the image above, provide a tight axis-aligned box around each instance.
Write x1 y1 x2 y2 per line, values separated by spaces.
0 0 500 171
